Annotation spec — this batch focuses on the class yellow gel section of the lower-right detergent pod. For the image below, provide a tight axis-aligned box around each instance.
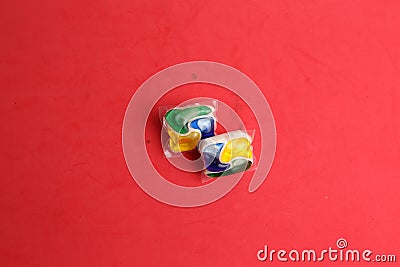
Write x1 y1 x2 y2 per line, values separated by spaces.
220 138 253 163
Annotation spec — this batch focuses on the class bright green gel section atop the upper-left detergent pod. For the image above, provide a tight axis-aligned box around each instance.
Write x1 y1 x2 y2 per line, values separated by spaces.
165 106 212 134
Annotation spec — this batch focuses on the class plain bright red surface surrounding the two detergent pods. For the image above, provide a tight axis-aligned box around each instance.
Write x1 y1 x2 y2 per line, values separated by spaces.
0 0 400 266
